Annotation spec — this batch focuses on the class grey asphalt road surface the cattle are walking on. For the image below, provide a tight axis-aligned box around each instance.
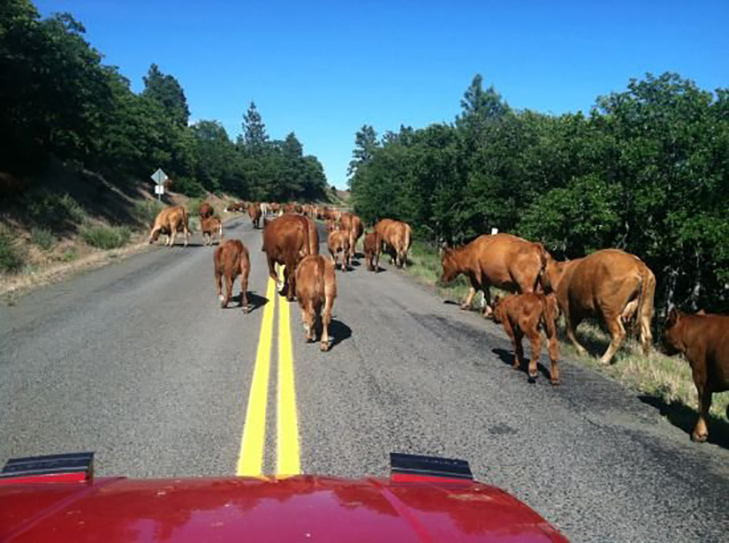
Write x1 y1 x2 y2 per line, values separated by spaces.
0 221 729 541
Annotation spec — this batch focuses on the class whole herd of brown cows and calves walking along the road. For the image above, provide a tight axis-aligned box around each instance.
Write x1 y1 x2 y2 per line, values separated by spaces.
149 202 729 441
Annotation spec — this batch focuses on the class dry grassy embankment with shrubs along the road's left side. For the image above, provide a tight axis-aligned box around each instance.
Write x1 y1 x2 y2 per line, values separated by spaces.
0 164 245 304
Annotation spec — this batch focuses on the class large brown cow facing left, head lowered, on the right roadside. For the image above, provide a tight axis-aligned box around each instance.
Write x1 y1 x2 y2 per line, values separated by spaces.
440 234 548 317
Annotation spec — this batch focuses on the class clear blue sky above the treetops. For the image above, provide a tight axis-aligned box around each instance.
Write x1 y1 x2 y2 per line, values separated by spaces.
36 0 729 188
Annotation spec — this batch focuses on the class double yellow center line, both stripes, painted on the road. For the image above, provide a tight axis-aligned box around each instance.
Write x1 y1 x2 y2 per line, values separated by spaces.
236 270 301 477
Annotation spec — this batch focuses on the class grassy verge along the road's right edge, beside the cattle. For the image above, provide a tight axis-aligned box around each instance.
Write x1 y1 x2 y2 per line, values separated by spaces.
407 241 729 427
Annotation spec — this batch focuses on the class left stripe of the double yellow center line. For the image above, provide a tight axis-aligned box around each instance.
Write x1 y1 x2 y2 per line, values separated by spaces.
236 278 278 477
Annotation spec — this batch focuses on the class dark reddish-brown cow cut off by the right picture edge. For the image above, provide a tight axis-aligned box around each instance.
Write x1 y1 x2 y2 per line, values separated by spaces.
663 309 729 442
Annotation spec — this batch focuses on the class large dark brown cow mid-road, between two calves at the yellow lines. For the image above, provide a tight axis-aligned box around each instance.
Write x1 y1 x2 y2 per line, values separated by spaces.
261 215 319 301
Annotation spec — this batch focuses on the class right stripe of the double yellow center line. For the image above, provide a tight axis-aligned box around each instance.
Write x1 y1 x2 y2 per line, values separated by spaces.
276 284 301 476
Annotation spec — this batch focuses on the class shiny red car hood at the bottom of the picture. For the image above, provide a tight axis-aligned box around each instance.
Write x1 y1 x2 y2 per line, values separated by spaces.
0 476 566 543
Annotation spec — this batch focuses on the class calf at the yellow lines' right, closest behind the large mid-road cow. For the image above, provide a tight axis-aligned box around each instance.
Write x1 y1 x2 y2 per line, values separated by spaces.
296 255 337 351
